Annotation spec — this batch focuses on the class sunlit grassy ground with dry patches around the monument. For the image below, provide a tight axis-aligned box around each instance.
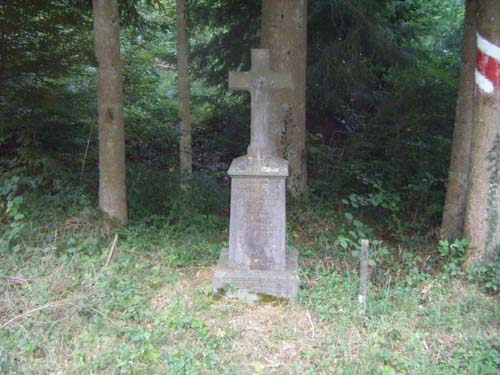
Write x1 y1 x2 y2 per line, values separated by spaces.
0 192 500 375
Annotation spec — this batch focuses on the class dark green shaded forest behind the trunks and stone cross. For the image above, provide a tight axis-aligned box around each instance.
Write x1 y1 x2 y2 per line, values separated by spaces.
0 0 463 226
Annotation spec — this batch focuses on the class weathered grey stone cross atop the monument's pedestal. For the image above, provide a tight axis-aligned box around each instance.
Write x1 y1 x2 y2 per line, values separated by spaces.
229 49 293 155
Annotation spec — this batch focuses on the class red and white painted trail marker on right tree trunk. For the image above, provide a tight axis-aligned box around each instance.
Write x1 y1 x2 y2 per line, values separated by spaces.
476 33 500 94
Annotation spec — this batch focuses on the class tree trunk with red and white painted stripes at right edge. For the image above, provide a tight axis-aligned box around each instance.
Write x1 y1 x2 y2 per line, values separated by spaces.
464 0 500 267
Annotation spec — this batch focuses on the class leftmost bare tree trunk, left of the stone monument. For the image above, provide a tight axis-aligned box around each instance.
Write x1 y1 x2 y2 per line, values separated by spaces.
93 0 127 225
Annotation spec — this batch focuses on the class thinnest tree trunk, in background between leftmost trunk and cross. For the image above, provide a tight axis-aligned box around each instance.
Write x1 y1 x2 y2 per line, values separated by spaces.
176 0 193 188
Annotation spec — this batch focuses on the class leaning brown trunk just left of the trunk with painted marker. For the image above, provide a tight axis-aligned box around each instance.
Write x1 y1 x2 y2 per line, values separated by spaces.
441 0 477 240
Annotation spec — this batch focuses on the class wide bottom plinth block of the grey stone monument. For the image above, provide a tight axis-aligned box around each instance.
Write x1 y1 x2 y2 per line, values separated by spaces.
213 248 299 302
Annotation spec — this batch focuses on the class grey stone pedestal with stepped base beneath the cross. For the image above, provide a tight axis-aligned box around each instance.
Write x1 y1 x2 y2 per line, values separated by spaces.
213 154 298 300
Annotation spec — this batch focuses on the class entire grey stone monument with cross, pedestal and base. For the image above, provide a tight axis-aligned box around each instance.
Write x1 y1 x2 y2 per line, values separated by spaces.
213 49 298 299
